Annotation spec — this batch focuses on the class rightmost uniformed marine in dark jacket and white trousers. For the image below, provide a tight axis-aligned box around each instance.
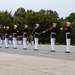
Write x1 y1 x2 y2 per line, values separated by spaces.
61 22 72 53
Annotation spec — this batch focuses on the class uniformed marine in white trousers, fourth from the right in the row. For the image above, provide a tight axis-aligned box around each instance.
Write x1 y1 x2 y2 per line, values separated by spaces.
23 25 28 50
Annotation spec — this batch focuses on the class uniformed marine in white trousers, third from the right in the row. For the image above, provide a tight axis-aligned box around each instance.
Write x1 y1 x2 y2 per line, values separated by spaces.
31 24 40 50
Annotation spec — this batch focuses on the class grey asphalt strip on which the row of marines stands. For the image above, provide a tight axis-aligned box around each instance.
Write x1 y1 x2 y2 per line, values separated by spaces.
0 44 75 60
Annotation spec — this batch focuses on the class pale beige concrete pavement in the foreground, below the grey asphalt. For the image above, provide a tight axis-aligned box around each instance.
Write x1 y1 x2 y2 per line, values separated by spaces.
0 53 75 75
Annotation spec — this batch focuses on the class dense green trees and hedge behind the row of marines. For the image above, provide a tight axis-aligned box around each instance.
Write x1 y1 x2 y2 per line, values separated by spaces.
0 8 75 44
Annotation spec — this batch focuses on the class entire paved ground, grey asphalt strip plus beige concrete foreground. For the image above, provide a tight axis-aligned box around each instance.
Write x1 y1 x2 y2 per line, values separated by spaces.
0 44 75 75
